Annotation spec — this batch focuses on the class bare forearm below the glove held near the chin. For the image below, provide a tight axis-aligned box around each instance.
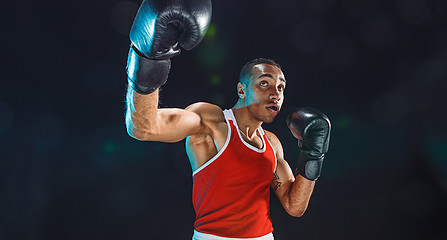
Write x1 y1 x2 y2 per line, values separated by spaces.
286 175 315 217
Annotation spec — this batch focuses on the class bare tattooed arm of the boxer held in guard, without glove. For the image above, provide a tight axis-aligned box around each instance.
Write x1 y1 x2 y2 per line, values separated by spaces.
266 131 315 217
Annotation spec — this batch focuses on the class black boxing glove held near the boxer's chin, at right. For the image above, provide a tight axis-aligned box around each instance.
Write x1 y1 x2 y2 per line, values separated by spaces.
287 108 331 181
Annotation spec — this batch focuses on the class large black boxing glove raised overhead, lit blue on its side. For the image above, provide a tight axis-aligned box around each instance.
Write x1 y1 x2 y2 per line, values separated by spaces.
127 0 211 94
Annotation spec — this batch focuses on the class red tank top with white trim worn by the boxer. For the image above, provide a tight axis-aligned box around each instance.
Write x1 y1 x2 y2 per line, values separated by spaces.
193 110 276 238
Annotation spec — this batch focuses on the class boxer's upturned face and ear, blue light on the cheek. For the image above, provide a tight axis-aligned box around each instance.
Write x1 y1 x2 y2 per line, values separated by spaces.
238 64 286 123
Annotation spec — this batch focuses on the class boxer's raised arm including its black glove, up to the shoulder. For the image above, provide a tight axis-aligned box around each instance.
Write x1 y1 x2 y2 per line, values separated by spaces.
126 0 211 142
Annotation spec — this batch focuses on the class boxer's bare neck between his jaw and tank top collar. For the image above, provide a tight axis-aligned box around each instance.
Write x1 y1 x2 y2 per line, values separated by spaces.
232 101 263 139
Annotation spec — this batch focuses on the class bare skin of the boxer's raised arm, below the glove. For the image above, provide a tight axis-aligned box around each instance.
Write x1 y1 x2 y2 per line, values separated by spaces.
126 88 203 142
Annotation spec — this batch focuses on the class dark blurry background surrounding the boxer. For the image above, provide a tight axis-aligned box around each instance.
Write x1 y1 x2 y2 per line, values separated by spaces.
0 0 447 240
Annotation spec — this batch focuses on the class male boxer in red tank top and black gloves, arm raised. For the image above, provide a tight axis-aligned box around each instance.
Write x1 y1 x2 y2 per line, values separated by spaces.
126 0 330 240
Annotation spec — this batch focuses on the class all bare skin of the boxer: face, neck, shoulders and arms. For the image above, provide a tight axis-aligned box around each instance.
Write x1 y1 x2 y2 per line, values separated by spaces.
126 64 315 217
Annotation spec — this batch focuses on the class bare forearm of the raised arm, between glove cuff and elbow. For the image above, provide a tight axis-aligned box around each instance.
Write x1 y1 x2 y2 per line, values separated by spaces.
126 87 159 140
